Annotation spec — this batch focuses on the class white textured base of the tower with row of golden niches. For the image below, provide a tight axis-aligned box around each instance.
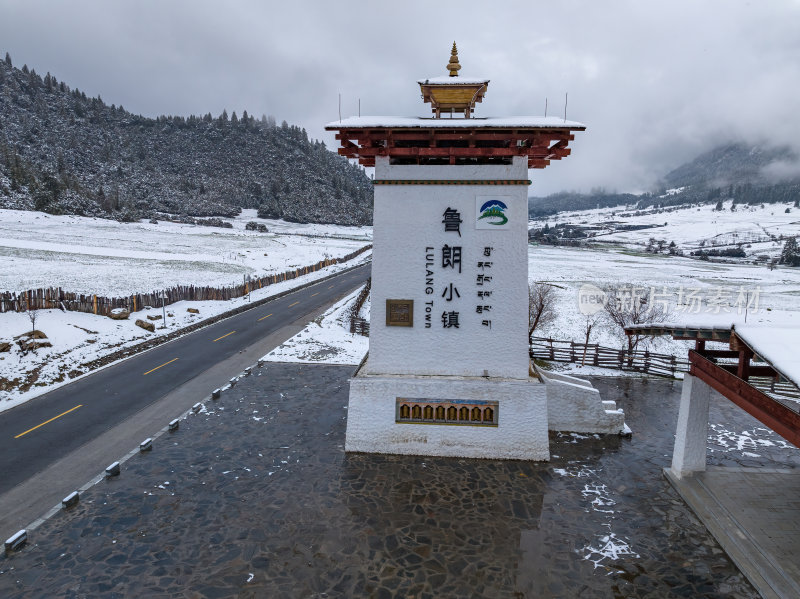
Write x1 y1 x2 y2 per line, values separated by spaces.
345 369 550 460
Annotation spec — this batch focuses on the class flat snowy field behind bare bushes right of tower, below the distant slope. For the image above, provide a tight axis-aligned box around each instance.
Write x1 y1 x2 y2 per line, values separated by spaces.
528 246 800 366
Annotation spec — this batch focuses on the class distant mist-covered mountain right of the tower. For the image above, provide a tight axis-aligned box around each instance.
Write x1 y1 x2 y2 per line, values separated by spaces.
528 142 800 217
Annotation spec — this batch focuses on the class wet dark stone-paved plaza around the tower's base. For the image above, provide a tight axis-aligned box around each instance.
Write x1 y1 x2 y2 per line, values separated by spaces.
0 364 800 598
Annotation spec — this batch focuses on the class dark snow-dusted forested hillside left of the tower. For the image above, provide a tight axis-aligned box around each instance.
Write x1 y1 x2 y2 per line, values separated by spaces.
0 54 372 224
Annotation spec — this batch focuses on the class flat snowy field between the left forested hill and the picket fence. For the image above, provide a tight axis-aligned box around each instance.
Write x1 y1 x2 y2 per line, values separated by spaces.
0 210 372 297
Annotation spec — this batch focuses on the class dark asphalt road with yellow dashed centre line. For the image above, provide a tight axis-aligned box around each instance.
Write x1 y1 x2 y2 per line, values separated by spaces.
0 265 371 495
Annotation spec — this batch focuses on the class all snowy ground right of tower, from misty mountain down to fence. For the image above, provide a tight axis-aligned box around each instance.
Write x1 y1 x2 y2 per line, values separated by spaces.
528 201 800 374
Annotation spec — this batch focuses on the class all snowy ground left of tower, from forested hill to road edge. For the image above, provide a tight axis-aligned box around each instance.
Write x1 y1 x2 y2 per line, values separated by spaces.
0 210 372 411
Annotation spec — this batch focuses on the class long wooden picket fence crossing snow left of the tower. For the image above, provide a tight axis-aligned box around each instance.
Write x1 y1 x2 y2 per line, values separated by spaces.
0 245 372 316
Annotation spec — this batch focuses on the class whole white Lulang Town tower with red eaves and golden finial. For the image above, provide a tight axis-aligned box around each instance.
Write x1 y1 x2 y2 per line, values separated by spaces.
326 44 585 460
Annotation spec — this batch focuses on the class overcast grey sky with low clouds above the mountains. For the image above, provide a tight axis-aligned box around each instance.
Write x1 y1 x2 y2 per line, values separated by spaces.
0 0 800 195
